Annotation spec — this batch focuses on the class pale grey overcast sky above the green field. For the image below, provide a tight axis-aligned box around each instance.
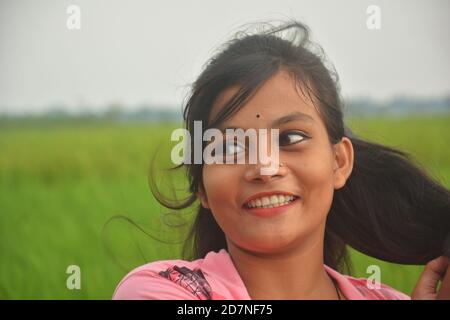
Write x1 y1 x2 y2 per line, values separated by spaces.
0 0 450 112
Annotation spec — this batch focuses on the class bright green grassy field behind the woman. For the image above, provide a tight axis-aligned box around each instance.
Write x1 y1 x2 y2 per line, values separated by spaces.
0 117 450 299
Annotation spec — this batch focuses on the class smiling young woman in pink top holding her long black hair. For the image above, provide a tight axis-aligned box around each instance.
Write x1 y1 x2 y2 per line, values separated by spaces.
114 22 450 299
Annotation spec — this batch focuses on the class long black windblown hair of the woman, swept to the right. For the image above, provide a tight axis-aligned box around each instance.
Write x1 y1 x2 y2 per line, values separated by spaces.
149 21 450 270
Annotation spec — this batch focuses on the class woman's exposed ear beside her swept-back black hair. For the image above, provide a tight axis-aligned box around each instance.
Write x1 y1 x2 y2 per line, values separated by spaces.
334 137 353 189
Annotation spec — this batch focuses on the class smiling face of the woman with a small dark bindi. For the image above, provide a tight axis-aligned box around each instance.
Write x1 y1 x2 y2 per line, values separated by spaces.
199 71 353 253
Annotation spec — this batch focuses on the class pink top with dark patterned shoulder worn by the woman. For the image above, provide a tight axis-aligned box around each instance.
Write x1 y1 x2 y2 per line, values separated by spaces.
113 249 410 300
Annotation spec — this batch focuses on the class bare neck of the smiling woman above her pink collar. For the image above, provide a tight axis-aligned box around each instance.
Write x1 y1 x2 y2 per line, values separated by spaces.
227 226 339 300
